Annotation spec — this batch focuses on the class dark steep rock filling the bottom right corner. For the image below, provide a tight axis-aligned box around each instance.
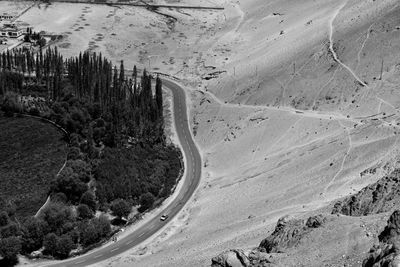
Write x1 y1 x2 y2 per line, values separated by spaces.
363 210 400 267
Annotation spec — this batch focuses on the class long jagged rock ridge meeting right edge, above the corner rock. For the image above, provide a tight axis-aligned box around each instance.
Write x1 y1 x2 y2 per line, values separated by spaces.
332 169 400 216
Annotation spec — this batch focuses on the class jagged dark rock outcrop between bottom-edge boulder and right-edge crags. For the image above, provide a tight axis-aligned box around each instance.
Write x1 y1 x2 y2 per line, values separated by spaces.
260 215 326 253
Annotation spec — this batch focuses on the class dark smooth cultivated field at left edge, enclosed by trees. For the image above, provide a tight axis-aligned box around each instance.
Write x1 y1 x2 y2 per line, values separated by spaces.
0 114 67 219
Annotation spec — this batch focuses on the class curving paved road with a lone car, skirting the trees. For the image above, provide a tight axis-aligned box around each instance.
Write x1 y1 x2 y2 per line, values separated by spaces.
46 79 201 267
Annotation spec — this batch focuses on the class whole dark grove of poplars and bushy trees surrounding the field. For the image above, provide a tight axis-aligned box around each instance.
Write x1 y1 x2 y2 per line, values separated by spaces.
0 48 182 262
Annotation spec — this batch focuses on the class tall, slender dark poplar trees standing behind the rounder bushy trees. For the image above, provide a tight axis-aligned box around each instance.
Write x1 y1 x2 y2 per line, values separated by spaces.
0 48 163 141
